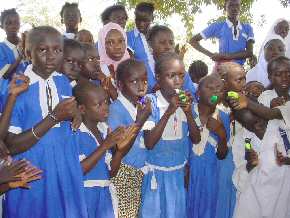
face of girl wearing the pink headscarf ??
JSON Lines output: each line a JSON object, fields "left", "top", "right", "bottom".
{"left": 105, "top": 29, "right": 126, "bottom": 61}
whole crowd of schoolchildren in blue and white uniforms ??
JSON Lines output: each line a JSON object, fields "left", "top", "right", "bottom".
{"left": 0, "top": 0, "right": 290, "bottom": 218}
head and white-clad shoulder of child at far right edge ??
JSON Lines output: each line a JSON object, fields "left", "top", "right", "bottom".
{"left": 258, "top": 56, "right": 290, "bottom": 107}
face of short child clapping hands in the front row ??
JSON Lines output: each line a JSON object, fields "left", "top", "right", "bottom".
{"left": 83, "top": 88, "right": 109, "bottom": 123}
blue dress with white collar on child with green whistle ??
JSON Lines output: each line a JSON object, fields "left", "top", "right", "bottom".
{"left": 187, "top": 105, "right": 228, "bottom": 218}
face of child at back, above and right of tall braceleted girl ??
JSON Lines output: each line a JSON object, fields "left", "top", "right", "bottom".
{"left": 63, "top": 7, "right": 81, "bottom": 30}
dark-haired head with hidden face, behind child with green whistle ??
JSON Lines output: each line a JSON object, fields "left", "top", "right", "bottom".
{"left": 188, "top": 60, "right": 208, "bottom": 85}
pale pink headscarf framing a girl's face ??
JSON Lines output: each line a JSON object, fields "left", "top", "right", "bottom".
{"left": 98, "top": 23, "right": 130, "bottom": 70}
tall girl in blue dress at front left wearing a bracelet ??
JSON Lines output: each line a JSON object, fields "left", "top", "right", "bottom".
{"left": 4, "top": 26, "right": 87, "bottom": 218}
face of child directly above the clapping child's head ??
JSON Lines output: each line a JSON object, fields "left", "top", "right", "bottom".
{"left": 81, "top": 47, "right": 101, "bottom": 80}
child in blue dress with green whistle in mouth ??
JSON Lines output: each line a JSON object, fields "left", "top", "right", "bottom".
{"left": 187, "top": 75, "right": 230, "bottom": 218}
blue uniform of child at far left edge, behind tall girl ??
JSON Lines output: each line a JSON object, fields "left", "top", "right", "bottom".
{"left": 0, "top": 39, "right": 28, "bottom": 113}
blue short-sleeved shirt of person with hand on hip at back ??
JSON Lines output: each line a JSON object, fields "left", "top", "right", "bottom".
{"left": 201, "top": 19, "right": 254, "bottom": 65}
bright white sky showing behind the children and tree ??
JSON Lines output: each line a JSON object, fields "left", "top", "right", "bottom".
{"left": 0, "top": 0, "right": 290, "bottom": 70}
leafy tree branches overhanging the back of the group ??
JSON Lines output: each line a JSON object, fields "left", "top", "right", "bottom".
{"left": 118, "top": 0, "right": 289, "bottom": 36}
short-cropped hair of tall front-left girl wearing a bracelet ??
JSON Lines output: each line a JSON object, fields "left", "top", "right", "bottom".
{"left": 28, "top": 26, "right": 63, "bottom": 50}
